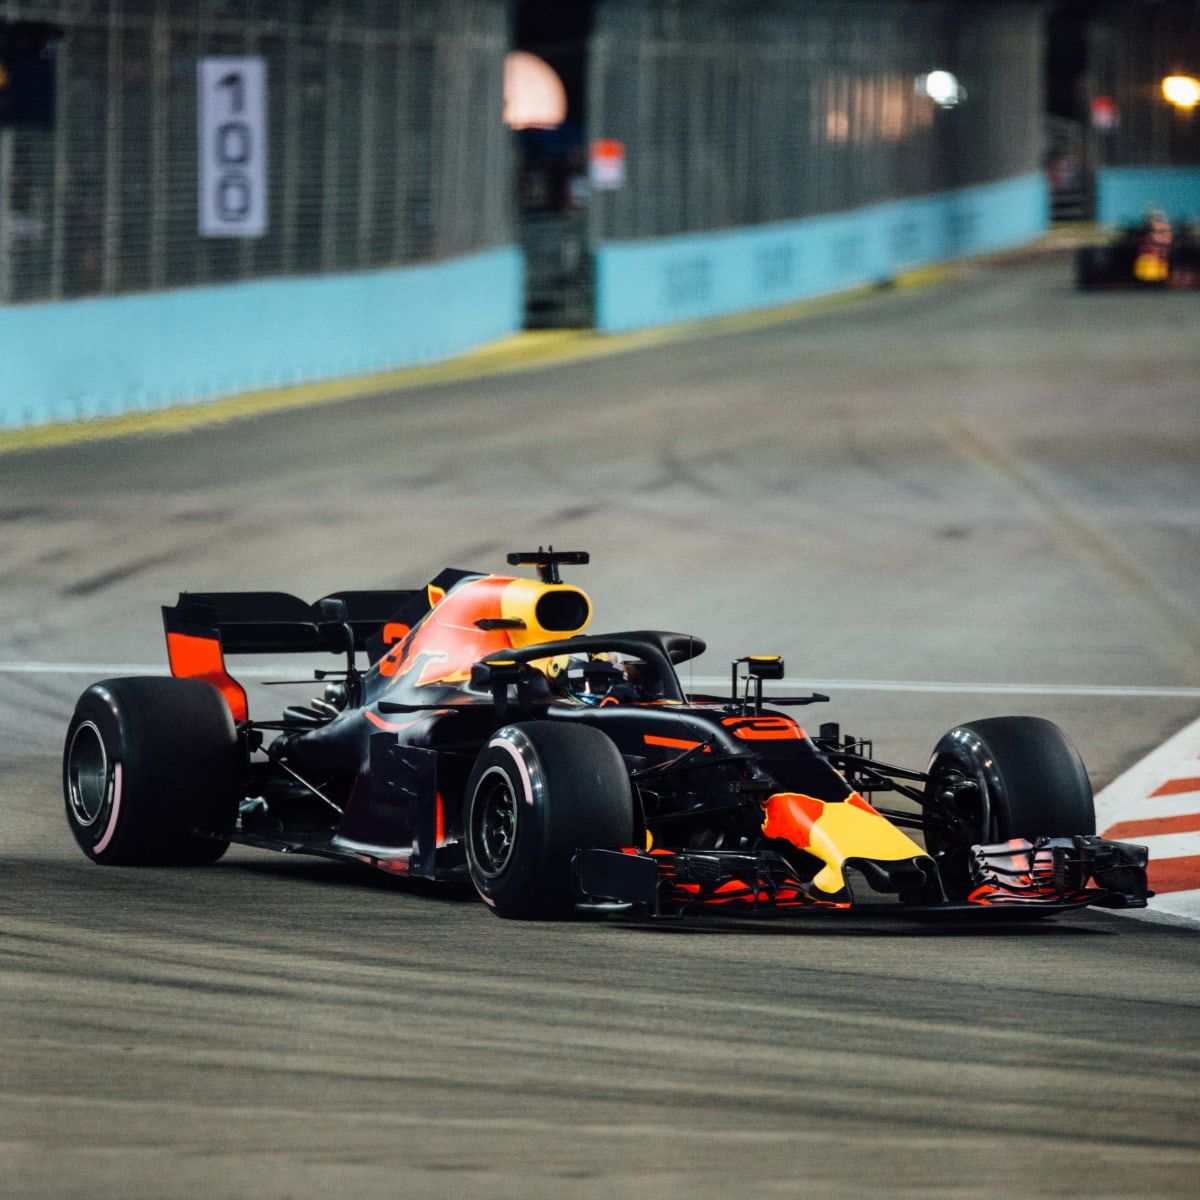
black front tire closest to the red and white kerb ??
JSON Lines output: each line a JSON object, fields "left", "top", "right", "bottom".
{"left": 925, "top": 716, "right": 1096, "bottom": 854}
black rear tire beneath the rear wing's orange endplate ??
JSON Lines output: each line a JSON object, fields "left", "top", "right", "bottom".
{"left": 62, "top": 678, "right": 242, "bottom": 866}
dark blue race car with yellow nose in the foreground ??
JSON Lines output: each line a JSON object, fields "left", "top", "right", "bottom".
{"left": 64, "top": 550, "right": 1147, "bottom": 918}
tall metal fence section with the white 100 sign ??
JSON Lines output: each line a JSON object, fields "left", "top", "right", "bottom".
{"left": 0, "top": 0, "right": 514, "bottom": 304}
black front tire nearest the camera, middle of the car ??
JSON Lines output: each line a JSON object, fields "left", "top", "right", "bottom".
{"left": 463, "top": 721, "right": 634, "bottom": 920}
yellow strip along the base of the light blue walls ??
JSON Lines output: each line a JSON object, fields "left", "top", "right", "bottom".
{"left": 0, "top": 266, "right": 954, "bottom": 454}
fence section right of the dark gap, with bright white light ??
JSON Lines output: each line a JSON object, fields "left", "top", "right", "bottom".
{"left": 589, "top": 0, "right": 1043, "bottom": 244}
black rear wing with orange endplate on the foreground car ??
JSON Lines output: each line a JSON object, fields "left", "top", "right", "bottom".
{"left": 162, "top": 588, "right": 417, "bottom": 721}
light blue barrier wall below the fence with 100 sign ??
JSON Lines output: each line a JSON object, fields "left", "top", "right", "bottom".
{"left": 0, "top": 246, "right": 524, "bottom": 426}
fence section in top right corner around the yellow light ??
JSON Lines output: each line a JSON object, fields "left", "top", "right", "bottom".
{"left": 1088, "top": 0, "right": 1200, "bottom": 167}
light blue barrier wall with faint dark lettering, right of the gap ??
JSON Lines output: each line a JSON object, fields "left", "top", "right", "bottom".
{"left": 596, "top": 174, "right": 1049, "bottom": 332}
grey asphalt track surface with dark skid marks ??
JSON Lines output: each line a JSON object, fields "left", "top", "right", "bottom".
{"left": 0, "top": 259, "right": 1200, "bottom": 1200}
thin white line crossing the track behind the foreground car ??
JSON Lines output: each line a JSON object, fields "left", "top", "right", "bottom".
{"left": 0, "top": 661, "right": 1200, "bottom": 700}
